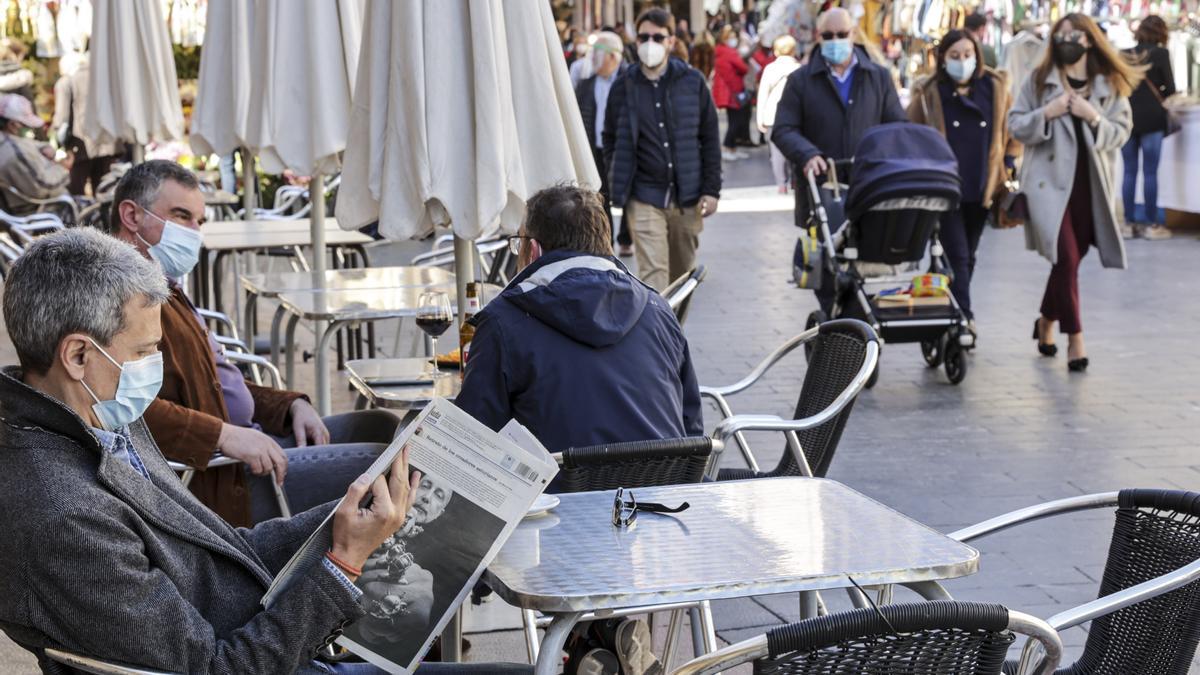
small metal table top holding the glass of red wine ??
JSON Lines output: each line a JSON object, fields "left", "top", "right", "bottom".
{"left": 346, "top": 359, "right": 462, "bottom": 411}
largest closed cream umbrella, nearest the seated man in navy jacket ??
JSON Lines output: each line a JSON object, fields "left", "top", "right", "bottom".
{"left": 337, "top": 0, "right": 600, "bottom": 326}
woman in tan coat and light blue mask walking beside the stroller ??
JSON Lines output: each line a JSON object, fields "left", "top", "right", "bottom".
{"left": 908, "top": 30, "right": 1020, "bottom": 334}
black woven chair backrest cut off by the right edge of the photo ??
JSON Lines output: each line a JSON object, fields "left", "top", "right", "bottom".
{"left": 1075, "top": 490, "right": 1200, "bottom": 675}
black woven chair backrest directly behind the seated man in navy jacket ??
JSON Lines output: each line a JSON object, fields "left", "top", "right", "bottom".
{"left": 557, "top": 436, "right": 713, "bottom": 492}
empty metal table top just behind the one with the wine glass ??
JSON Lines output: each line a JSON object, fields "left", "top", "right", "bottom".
{"left": 241, "top": 267, "right": 454, "bottom": 298}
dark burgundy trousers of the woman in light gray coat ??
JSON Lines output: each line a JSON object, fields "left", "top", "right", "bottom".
{"left": 1042, "top": 177, "right": 1096, "bottom": 334}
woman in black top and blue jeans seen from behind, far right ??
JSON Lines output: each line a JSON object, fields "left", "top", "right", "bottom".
{"left": 1121, "top": 14, "right": 1175, "bottom": 239}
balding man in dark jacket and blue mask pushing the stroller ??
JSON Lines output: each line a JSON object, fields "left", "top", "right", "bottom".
{"left": 770, "top": 7, "right": 908, "bottom": 312}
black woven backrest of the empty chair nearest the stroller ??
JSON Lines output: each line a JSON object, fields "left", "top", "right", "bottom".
{"left": 770, "top": 319, "right": 877, "bottom": 477}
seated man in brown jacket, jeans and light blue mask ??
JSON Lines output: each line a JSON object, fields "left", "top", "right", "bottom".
{"left": 110, "top": 161, "right": 398, "bottom": 525}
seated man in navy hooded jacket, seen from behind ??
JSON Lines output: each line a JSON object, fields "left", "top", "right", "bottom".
{"left": 456, "top": 185, "right": 704, "bottom": 468}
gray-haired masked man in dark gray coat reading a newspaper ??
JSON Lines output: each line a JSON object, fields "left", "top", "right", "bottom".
{"left": 0, "top": 228, "right": 458, "bottom": 674}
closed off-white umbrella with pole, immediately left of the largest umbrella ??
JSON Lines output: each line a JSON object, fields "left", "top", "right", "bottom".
{"left": 245, "top": 0, "right": 364, "bottom": 414}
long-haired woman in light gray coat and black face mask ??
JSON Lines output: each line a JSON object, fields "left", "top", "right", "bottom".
{"left": 1008, "top": 14, "right": 1141, "bottom": 372}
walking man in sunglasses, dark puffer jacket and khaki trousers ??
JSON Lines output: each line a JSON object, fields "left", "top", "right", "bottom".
{"left": 602, "top": 8, "right": 721, "bottom": 291}
